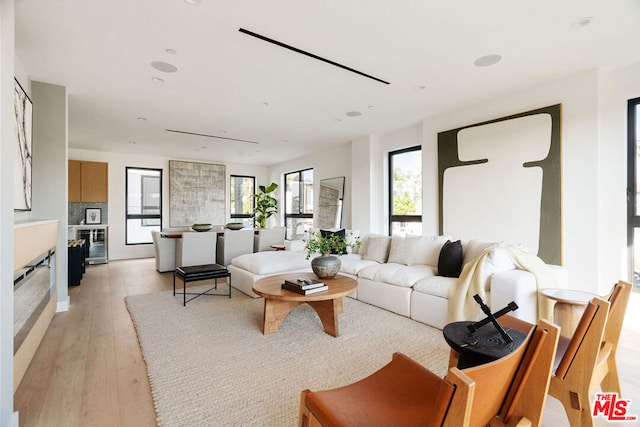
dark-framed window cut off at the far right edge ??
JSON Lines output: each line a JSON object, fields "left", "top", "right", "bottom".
{"left": 627, "top": 98, "right": 640, "bottom": 288}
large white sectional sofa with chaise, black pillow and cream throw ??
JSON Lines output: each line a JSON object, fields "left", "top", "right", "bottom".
{"left": 229, "top": 235, "right": 567, "bottom": 329}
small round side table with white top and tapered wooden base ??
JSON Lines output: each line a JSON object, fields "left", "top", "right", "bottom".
{"left": 540, "top": 289, "right": 598, "bottom": 338}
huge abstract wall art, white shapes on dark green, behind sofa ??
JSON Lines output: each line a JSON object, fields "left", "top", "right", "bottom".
{"left": 438, "top": 104, "right": 562, "bottom": 264}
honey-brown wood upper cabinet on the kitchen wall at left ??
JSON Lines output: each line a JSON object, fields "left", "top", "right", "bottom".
{"left": 68, "top": 160, "right": 109, "bottom": 203}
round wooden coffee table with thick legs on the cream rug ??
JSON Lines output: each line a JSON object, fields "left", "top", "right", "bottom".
{"left": 253, "top": 273, "right": 358, "bottom": 337}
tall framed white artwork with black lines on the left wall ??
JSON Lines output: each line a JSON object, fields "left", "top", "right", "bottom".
{"left": 13, "top": 79, "right": 33, "bottom": 211}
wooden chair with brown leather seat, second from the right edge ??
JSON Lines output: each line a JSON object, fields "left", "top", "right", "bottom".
{"left": 549, "top": 297, "right": 612, "bottom": 427}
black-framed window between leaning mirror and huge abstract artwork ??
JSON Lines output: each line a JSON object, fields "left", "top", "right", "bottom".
{"left": 389, "top": 147, "right": 422, "bottom": 235}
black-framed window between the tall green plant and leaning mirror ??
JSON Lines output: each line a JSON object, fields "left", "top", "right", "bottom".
{"left": 284, "top": 169, "right": 313, "bottom": 239}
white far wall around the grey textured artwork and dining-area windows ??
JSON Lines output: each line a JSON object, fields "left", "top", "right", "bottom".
{"left": 69, "top": 148, "right": 267, "bottom": 260}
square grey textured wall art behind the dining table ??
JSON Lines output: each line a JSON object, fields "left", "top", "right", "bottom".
{"left": 169, "top": 160, "right": 226, "bottom": 227}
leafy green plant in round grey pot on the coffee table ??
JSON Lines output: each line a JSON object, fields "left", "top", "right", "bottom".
{"left": 305, "top": 231, "right": 361, "bottom": 279}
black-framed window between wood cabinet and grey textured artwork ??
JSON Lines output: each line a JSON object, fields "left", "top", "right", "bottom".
{"left": 125, "top": 167, "right": 162, "bottom": 245}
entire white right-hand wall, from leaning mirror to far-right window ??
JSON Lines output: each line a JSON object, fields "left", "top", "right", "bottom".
{"left": 344, "top": 64, "right": 640, "bottom": 294}
